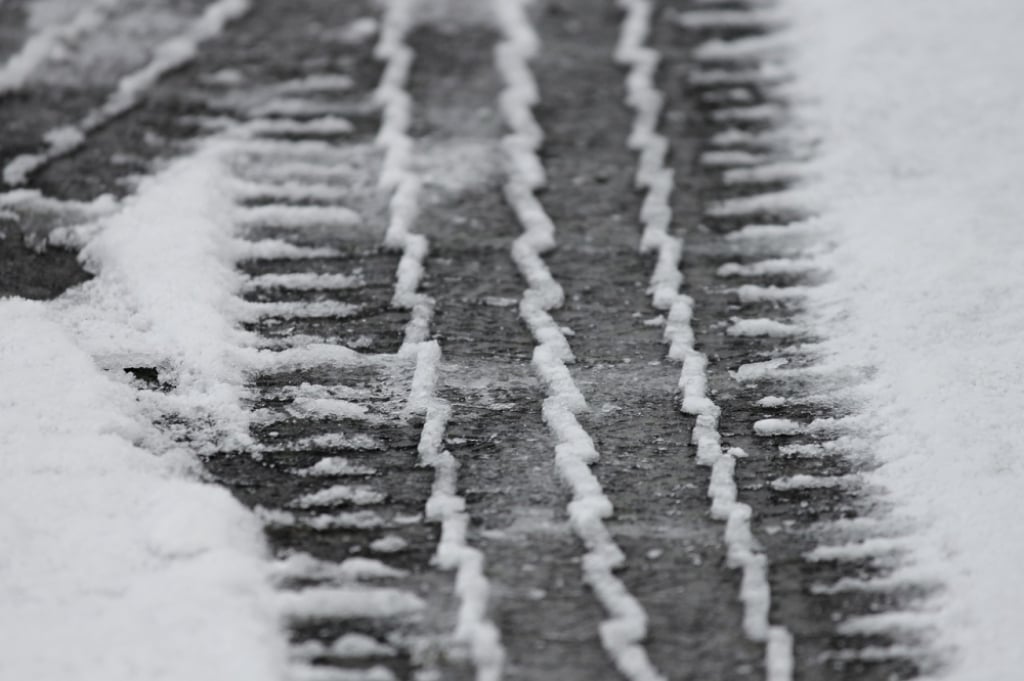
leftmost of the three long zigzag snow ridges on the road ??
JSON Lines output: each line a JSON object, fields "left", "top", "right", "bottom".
{"left": 375, "top": 0, "right": 505, "bottom": 681}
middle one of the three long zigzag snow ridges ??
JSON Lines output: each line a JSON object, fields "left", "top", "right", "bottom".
{"left": 494, "top": 0, "right": 665, "bottom": 681}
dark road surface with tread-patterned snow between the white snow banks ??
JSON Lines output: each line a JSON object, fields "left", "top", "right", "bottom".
{"left": 0, "top": 0, "right": 930, "bottom": 681}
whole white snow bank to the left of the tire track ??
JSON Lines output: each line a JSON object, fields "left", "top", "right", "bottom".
{"left": 0, "top": 144, "right": 287, "bottom": 681}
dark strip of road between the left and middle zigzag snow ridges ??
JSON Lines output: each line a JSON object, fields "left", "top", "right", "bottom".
{"left": 401, "top": 14, "right": 616, "bottom": 681}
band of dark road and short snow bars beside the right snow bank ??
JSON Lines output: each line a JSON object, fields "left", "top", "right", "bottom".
{"left": 670, "top": 2, "right": 931, "bottom": 680}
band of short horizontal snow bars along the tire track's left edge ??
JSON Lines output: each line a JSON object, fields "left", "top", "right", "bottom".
{"left": 209, "top": 99, "right": 437, "bottom": 681}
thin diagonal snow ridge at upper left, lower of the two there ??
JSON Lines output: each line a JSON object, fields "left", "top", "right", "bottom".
{"left": 3, "top": 0, "right": 251, "bottom": 184}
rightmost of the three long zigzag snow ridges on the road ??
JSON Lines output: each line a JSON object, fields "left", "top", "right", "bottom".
{"left": 614, "top": 0, "right": 793, "bottom": 681}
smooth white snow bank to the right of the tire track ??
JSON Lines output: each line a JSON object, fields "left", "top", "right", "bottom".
{"left": 784, "top": 0, "right": 1024, "bottom": 681}
